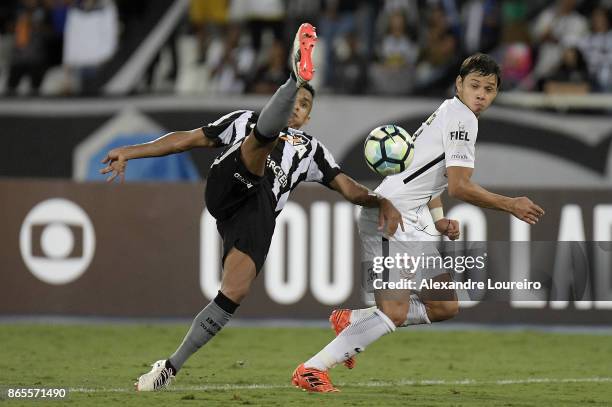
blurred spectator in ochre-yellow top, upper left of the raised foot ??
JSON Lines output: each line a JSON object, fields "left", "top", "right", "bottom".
{"left": 189, "top": 0, "right": 229, "bottom": 62}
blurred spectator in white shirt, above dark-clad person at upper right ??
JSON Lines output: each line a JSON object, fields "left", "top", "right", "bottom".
{"left": 532, "top": 0, "right": 588, "bottom": 81}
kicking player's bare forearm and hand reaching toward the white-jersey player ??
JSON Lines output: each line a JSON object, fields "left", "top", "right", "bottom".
{"left": 329, "top": 173, "right": 404, "bottom": 236}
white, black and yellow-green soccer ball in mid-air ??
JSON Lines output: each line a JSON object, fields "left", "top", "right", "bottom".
{"left": 363, "top": 124, "right": 414, "bottom": 177}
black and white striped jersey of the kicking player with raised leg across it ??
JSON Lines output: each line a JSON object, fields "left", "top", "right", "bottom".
{"left": 202, "top": 110, "right": 341, "bottom": 215}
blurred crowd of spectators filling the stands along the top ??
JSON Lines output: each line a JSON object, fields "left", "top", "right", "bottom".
{"left": 0, "top": 0, "right": 612, "bottom": 96}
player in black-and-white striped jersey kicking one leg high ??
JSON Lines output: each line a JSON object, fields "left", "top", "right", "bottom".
{"left": 101, "top": 24, "right": 403, "bottom": 391}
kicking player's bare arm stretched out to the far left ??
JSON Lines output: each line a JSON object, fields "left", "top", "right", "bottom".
{"left": 100, "top": 128, "right": 217, "bottom": 182}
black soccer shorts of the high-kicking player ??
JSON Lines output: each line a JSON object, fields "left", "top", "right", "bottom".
{"left": 205, "top": 143, "right": 276, "bottom": 274}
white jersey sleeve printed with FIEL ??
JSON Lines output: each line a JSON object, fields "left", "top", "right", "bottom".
{"left": 442, "top": 115, "right": 478, "bottom": 168}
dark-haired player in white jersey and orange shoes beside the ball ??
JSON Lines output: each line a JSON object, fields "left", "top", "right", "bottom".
{"left": 292, "top": 54, "right": 544, "bottom": 392}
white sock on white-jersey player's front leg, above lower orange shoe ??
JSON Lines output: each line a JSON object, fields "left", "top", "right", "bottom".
{"left": 304, "top": 309, "right": 395, "bottom": 371}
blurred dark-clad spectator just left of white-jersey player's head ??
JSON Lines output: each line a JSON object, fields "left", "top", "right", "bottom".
{"left": 415, "top": 5, "right": 460, "bottom": 92}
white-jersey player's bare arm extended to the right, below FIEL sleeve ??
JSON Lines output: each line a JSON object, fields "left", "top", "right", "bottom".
{"left": 447, "top": 167, "right": 544, "bottom": 225}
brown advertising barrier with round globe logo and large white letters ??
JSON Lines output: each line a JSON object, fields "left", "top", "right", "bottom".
{"left": 0, "top": 179, "right": 612, "bottom": 325}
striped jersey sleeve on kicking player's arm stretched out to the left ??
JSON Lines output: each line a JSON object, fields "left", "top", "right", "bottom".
{"left": 202, "top": 110, "right": 256, "bottom": 147}
